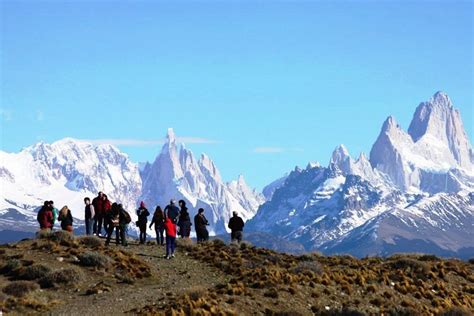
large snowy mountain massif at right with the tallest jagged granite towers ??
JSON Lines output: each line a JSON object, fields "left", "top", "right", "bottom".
{"left": 247, "top": 92, "right": 474, "bottom": 256}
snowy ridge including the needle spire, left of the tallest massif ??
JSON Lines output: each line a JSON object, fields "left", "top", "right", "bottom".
{"left": 0, "top": 130, "right": 263, "bottom": 241}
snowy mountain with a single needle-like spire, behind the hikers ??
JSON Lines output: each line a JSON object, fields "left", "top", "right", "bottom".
{"left": 142, "top": 129, "right": 264, "bottom": 234}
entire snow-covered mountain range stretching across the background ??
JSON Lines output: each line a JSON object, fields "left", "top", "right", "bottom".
{"left": 0, "top": 92, "right": 474, "bottom": 258}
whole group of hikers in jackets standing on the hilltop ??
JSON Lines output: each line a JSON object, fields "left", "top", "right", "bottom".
{"left": 37, "top": 192, "right": 248, "bottom": 259}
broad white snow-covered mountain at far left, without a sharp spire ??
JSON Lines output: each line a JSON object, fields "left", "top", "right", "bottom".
{"left": 0, "top": 138, "right": 141, "bottom": 239}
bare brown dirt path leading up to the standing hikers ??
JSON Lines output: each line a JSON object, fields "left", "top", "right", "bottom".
{"left": 50, "top": 243, "right": 231, "bottom": 315}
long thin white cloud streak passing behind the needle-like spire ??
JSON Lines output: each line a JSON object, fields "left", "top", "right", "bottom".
{"left": 80, "top": 137, "right": 219, "bottom": 147}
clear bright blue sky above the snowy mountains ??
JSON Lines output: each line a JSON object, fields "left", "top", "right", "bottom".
{"left": 0, "top": 0, "right": 474, "bottom": 189}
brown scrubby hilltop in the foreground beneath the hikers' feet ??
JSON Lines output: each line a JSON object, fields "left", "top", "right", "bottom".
{"left": 0, "top": 232, "right": 474, "bottom": 315}
